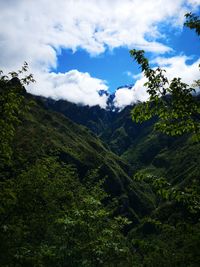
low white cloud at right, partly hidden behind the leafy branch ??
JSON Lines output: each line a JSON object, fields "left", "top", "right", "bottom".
{"left": 114, "top": 55, "right": 200, "bottom": 109}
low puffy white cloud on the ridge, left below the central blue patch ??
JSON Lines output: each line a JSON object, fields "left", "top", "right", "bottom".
{"left": 29, "top": 70, "right": 108, "bottom": 108}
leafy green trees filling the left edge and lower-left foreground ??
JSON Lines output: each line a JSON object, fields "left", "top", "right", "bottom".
{"left": 0, "top": 68, "right": 132, "bottom": 267}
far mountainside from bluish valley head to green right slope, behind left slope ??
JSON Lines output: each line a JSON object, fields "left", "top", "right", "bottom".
{"left": 41, "top": 98, "right": 200, "bottom": 188}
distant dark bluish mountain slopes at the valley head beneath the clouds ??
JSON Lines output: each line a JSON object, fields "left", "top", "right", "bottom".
{"left": 37, "top": 97, "right": 152, "bottom": 155}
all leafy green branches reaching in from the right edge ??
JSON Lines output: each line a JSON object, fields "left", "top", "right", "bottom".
{"left": 130, "top": 13, "right": 200, "bottom": 211}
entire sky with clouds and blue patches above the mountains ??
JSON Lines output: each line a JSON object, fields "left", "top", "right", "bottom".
{"left": 0, "top": 0, "right": 200, "bottom": 108}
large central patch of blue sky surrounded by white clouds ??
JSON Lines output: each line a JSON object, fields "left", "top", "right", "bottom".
{"left": 52, "top": 48, "right": 135, "bottom": 92}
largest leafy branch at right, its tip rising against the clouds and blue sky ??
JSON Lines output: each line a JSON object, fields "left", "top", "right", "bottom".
{"left": 130, "top": 49, "right": 200, "bottom": 139}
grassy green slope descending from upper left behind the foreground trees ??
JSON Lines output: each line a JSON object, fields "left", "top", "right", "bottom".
{"left": 11, "top": 95, "right": 153, "bottom": 222}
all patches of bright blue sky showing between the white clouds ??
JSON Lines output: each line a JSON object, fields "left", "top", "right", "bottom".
{"left": 54, "top": 23, "right": 200, "bottom": 92}
